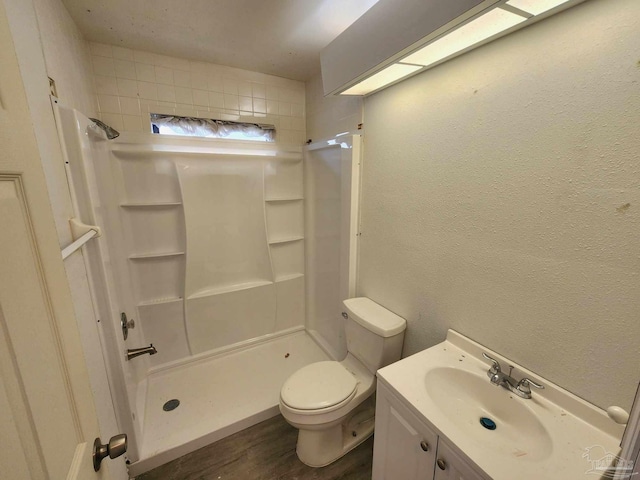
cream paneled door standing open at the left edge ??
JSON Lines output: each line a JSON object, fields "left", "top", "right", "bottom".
{"left": 0, "top": 2, "right": 110, "bottom": 480}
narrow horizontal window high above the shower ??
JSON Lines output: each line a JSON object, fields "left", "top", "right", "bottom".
{"left": 150, "top": 113, "right": 276, "bottom": 142}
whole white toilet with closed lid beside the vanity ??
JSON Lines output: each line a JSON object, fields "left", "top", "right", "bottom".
{"left": 280, "top": 297, "right": 406, "bottom": 467}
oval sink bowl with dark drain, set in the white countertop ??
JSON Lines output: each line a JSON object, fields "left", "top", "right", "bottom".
{"left": 424, "top": 367, "right": 552, "bottom": 461}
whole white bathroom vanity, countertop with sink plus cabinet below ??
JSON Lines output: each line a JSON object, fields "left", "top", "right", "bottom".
{"left": 373, "top": 330, "right": 624, "bottom": 480}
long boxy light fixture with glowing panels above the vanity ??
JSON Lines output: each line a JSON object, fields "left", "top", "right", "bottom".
{"left": 322, "top": 0, "right": 584, "bottom": 95}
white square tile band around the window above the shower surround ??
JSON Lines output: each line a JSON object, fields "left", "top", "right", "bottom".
{"left": 90, "top": 43, "right": 306, "bottom": 145}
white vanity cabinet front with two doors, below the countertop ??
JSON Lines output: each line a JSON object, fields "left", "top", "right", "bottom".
{"left": 373, "top": 382, "right": 486, "bottom": 480}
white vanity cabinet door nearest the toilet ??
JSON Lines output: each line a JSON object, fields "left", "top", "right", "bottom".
{"left": 373, "top": 384, "right": 438, "bottom": 480}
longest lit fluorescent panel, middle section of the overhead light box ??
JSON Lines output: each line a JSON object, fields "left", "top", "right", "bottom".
{"left": 401, "top": 7, "right": 524, "bottom": 66}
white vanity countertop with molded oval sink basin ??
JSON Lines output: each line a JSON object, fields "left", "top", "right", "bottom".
{"left": 377, "top": 330, "right": 624, "bottom": 480}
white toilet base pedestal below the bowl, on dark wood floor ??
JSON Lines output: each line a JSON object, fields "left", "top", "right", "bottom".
{"left": 296, "top": 396, "right": 375, "bottom": 467}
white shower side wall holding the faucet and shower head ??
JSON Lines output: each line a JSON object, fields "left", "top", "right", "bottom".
{"left": 53, "top": 104, "right": 149, "bottom": 462}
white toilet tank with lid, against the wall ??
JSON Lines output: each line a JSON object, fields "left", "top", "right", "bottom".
{"left": 343, "top": 297, "right": 407, "bottom": 373}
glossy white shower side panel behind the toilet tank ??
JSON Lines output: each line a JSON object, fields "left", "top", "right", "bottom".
{"left": 304, "top": 135, "right": 361, "bottom": 359}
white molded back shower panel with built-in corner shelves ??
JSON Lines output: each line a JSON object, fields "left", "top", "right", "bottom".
{"left": 111, "top": 142, "right": 305, "bottom": 367}
